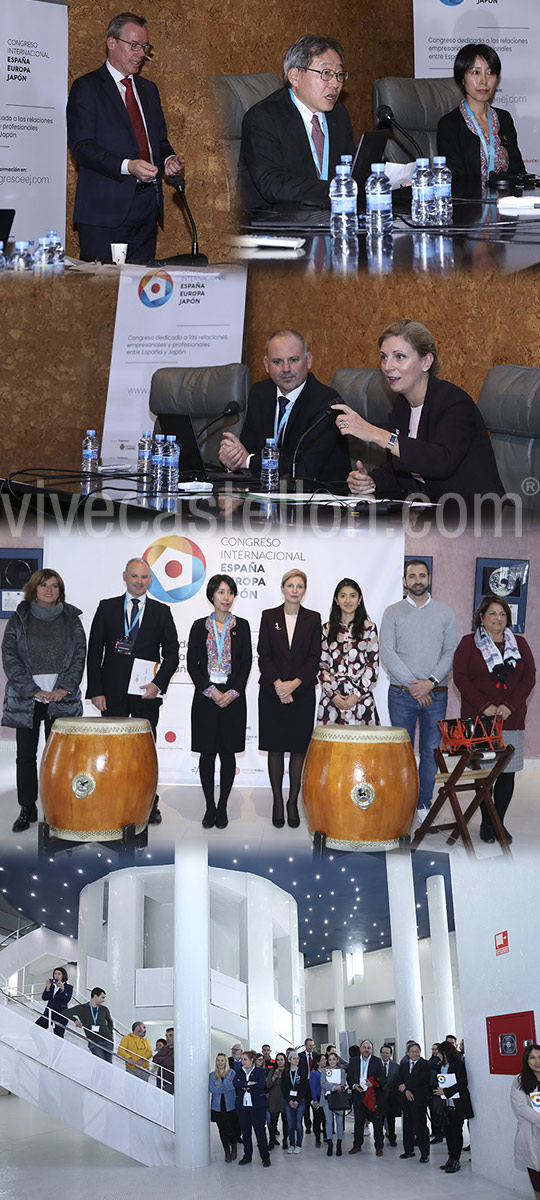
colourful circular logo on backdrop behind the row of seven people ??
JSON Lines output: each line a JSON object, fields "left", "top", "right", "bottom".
{"left": 143, "top": 534, "right": 206, "bottom": 604}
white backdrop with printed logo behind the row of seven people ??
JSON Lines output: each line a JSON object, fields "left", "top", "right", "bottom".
{"left": 43, "top": 526, "right": 403, "bottom": 787}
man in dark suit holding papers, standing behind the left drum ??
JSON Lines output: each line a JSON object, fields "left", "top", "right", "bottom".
{"left": 86, "top": 558, "right": 179, "bottom": 824}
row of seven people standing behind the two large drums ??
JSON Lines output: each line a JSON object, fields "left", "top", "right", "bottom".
{"left": 2, "top": 559, "right": 535, "bottom": 842}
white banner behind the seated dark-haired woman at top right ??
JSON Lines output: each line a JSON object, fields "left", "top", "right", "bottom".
{"left": 414, "top": 0, "right": 540, "bottom": 172}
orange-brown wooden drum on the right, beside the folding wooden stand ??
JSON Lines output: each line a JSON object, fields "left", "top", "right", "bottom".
{"left": 302, "top": 725, "right": 418, "bottom": 850}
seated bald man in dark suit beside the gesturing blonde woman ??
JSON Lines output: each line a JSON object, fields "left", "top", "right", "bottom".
{"left": 220, "top": 329, "right": 350, "bottom": 481}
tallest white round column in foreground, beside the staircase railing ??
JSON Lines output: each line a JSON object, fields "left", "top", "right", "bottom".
{"left": 174, "top": 840, "right": 210, "bottom": 1168}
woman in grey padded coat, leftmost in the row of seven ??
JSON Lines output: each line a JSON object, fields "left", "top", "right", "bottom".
{"left": 2, "top": 569, "right": 86, "bottom": 833}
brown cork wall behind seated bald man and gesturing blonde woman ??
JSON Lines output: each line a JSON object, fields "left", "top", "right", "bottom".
{"left": 0, "top": 269, "right": 540, "bottom": 475}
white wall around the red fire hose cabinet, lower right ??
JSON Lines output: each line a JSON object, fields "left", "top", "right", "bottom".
{"left": 450, "top": 851, "right": 540, "bottom": 1196}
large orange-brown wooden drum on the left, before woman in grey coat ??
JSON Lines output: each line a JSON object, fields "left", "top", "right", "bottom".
{"left": 40, "top": 716, "right": 157, "bottom": 841}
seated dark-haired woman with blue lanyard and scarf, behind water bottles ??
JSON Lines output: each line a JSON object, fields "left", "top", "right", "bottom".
{"left": 437, "top": 43, "right": 526, "bottom": 186}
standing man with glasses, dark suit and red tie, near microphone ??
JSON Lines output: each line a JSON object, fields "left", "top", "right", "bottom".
{"left": 67, "top": 12, "right": 184, "bottom": 263}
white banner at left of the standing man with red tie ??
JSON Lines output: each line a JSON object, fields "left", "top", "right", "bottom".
{"left": 0, "top": 0, "right": 67, "bottom": 245}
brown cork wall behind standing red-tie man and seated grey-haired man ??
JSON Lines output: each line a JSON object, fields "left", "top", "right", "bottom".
{"left": 67, "top": 0, "right": 413, "bottom": 258}
